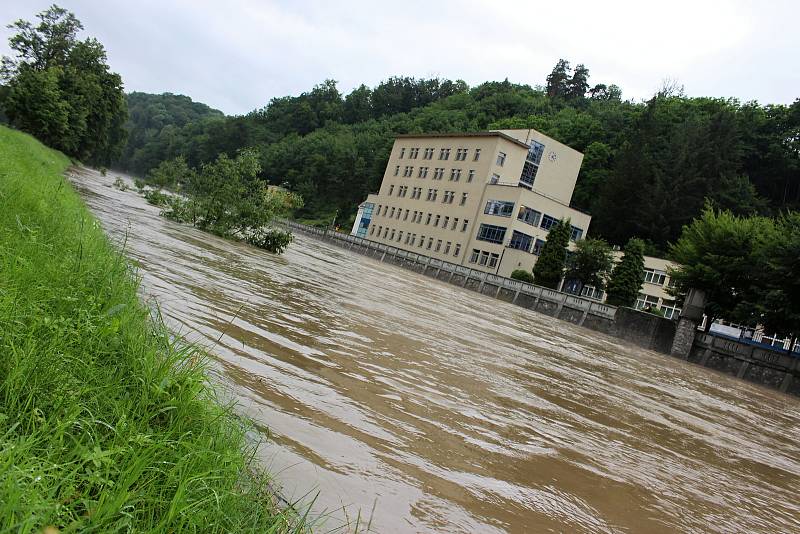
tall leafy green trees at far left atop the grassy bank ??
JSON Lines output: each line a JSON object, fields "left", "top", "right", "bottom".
{"left": 1, "top": 5, "right": 127, "bottom": 165}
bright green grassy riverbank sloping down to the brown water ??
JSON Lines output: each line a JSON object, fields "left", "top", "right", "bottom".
{"left": 0, "top": 127, "right": 290, "bottom": 532}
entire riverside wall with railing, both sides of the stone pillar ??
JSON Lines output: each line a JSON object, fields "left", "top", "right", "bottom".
{"left": 280, "top": 220, "right": 800, "bottom": 395}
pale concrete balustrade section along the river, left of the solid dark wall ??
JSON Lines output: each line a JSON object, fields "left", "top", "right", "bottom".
{"left": 279, "top": 219, "right": 617, "bottom": 325}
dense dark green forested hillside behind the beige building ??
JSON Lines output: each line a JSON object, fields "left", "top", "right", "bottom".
{"left": 115, "top": 66, "right": 800, "bottom": 251}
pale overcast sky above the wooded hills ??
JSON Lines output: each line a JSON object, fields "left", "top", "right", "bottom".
{"left": 0, "top": 0, "right": 800, "bottom": 114}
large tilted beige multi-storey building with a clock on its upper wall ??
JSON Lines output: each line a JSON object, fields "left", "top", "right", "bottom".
{"left": 354, "top": 130, "right": 591, "bottom": 276}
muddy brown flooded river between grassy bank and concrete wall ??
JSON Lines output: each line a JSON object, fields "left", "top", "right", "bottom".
{"left": 73, "top": 172, "right": 800, "bottom": 533}
